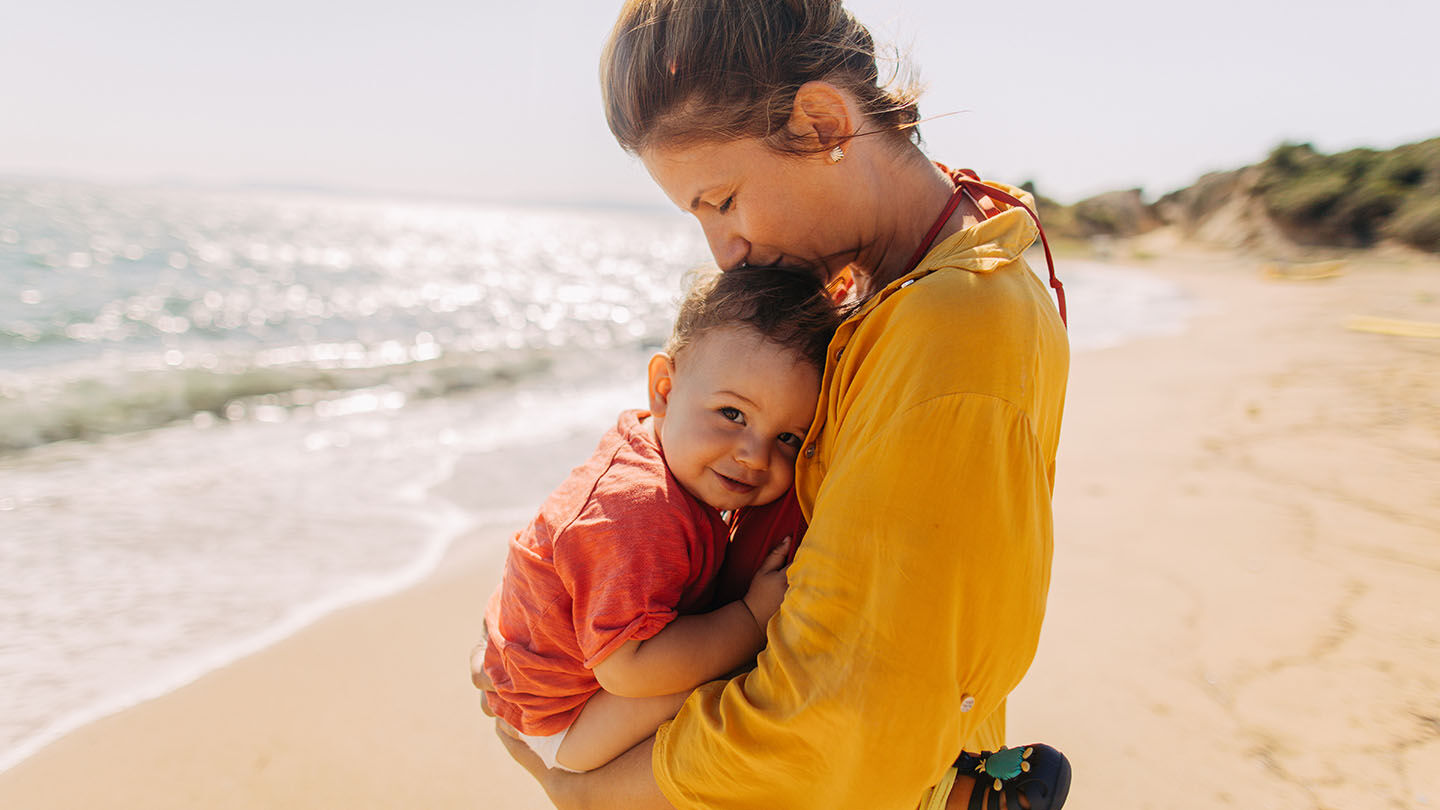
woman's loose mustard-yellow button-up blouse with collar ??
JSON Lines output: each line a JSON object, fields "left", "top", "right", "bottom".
{"left": 652, "top": 187, "right": 1070, "bottom": 810}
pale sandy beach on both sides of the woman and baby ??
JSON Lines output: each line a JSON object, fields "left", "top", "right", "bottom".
{"left": 0, "top": 249, "right": 1440, "bottom": 810}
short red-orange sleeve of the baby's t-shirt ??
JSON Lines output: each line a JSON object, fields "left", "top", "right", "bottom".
{"left": 554, "top": 493, "right": 696, "bottom": 669}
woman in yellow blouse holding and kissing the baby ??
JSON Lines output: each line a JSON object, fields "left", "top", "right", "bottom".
{"left": 478, "top": 0, "right": 1068, "bottom": 810}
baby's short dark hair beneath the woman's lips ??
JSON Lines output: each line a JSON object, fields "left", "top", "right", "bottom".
{"left": 665, "top": 265, "right": 844, "bottom": 373}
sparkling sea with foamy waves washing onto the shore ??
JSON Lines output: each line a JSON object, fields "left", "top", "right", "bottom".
{"left": 0, "top": 179, "right": 1191, "bottom": 771}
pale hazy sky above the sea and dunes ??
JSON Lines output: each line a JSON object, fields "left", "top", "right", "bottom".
{"left": 0, "top": 0, "right": 1440, "bottom": 206}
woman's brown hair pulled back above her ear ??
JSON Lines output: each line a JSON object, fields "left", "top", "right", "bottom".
{"left": 600, "top": 0, "right": 920, "bottom": 154}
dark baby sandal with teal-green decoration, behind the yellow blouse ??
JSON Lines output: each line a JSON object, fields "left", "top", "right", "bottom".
{"left": 955, "top": 744, "right": 1070, "bottom": 810}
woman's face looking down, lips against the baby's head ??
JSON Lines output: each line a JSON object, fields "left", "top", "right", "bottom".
{"left": 641, "top": 138, "right": 863, "bottom": 280}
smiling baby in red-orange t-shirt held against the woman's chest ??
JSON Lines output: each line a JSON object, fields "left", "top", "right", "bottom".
{"left": 484, "top": 268, "right": 840, "bottom": 771}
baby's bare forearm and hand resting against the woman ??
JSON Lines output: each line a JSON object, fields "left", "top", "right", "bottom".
{"left": 595, "top": 540, "right": 789, "bottom": 698}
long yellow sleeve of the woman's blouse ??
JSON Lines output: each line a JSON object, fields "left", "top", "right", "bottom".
{"left": 652, "top": 393, "right": 1051, "bottom": 810}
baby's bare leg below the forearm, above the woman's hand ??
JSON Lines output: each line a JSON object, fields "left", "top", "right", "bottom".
{"left": 554, "top": 689, "right": 690, "bottom": 771}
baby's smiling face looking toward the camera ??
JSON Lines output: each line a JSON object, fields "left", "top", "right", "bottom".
{"left": 651, "top": 327, "right": 819, "bottom": 510}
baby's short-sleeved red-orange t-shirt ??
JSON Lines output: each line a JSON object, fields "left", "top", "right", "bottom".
{"left": 485, "top": 411, "right": 729, "bottom": 735}
